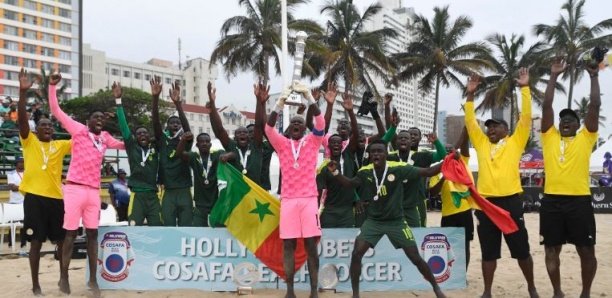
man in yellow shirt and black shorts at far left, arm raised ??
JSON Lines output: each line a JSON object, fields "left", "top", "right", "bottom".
{"left": 13, "top": 68, "right": 71, "bottom": 296}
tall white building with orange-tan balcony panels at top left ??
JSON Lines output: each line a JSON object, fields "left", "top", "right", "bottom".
{"left": 0, "top": 0, "right": 82, "bottom": 98}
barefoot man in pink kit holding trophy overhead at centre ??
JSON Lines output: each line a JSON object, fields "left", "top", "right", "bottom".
{"left": 266, "top": 82, "right": 325, "bottom": 297}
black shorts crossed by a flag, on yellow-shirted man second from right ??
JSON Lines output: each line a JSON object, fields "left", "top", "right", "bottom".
{"left": 475, "top": 194, "right": 530, "bottom": 261}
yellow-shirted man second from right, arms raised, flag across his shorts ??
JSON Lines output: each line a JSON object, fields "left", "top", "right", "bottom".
{"left": 464, "top": 68, "right": 538, "bottom": 297}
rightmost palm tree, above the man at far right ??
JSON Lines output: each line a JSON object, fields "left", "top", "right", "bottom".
{"left": 533, "top": 0, "right": 612, "bottom": 108}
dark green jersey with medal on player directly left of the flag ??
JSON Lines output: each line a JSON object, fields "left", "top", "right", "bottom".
{"left": 189, "top": 150, "right": 225, "bottom": 210}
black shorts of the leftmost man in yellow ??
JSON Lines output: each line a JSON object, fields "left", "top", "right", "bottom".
{"left": 23, "top": 193, "right": 66, "bottom": 242}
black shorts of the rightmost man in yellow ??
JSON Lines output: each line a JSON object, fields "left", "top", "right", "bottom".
{"left": 540, "top": 194, "right": 595, "bottom": 247}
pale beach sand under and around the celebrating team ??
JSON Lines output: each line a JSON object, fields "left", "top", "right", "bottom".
{"left": 0, "top": 212, "right": 612, "bottom": 298}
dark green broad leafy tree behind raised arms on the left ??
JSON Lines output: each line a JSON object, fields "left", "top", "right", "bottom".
{"left": 60, "top": 87, "right": 171, "bottom": 135}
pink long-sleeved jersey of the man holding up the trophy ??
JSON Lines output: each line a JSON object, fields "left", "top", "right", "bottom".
{"left": 265, "top": 114, "right": 325, "bottom": 199}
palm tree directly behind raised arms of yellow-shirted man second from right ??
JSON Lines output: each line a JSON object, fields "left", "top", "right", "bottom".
{"left": 478, "top": 34, "right": 565, "bottom": 131}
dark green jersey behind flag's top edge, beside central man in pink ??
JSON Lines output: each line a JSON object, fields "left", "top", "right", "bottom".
{"left": 225, "top": 140, "right": 263, "bottom": 186}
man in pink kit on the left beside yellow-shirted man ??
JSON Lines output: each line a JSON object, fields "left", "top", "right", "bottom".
{"left": 49, "top": 73, "right": 125, "bottom": 296}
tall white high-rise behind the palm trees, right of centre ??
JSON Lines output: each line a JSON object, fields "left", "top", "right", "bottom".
{"left": 366, "top": 0, "right": 435, "bottom": 134}
